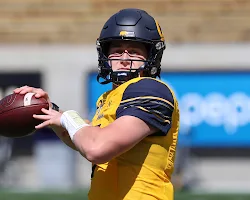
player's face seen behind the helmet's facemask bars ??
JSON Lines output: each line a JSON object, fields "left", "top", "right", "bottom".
{"left": 108, "top": 41, "right": 147, "bottom": 71}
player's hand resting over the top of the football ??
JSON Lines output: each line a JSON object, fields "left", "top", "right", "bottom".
{"left": 13, "top": 85, "right": 52, "bottom": 108}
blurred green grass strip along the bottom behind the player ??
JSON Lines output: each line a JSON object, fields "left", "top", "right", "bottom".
{"left": 0, "top": 191, "right": 250, "bottom": 200}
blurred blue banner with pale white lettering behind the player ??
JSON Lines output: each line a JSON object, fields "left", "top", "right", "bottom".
{"left": 88, "top": 71, "right": 250, "bottom": 147}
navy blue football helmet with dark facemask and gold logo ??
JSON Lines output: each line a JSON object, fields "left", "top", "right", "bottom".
{"left": 96, "top": 8, "right": 165, "bottom": 84}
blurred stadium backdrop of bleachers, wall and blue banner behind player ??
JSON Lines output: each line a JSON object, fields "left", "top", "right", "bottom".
{"left": 0, "top": 0, "right": 250, "bottom": 200}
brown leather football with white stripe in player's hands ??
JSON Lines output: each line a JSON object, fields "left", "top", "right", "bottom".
{"left": 0, "top": 93, "right": 49, "bottom": 138}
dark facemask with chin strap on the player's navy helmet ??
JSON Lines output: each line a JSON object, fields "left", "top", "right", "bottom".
{"left": 97, "top": 40, "right": 163, "bottom": 85}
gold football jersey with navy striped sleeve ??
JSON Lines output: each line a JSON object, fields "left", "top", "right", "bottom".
{"left": 89, "top": 77, "right": 179, "bottom": 200}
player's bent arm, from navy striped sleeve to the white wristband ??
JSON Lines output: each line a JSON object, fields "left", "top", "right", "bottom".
{"left": 73, "top": 79, "right": 174, "bottom": 164}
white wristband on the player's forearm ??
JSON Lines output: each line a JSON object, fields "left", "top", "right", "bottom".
{"left": 60, "top": 110, "right": 89, "bottom": 141}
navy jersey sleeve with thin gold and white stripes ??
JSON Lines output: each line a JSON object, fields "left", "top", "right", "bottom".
{"left": 116, "top": 79, "right": 174, "bottom": 135}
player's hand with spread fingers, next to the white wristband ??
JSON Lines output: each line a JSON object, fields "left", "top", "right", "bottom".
{"left": 33, "top": 108, "right": 62, "bottom": 129}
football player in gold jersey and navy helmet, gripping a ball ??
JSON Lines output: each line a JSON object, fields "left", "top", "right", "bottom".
{"left": 15, "top": 9, "right": 179, "bottom": 200}
